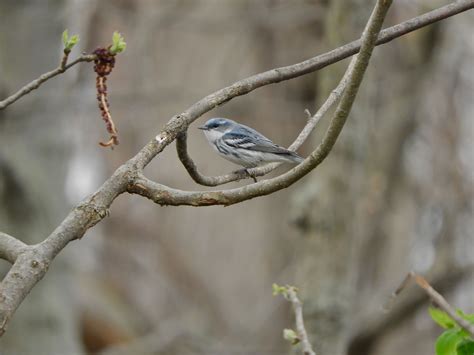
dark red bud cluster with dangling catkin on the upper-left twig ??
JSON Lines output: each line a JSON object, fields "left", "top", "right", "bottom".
{"left": 93, "top": 48, "right": 119, "bottom": 148}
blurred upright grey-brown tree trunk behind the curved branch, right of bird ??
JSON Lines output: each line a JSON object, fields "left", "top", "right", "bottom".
{"left": 294, "top": 0, "right": 372, "bottom": 355}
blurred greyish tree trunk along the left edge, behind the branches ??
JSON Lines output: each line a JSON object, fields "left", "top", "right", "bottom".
{"left": 0, "top": 1, "right": 81, "bottom": 355}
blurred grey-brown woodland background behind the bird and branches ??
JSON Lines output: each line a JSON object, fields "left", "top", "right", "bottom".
{"left": 0, "top": 0, "right": 474, "bottom": 355}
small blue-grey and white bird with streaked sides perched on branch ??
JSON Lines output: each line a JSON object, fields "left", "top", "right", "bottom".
{"left": 199, "top": 118, "right": 303, "bottom": 169}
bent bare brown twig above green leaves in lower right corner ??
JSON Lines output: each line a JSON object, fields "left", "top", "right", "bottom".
{"left": 390, "top": 271, "right": 474, "bottom": 337}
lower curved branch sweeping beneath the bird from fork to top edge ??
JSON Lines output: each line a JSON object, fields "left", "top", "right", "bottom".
{"left": 127, "top": 0, "right": 391, "bottom": 206}
